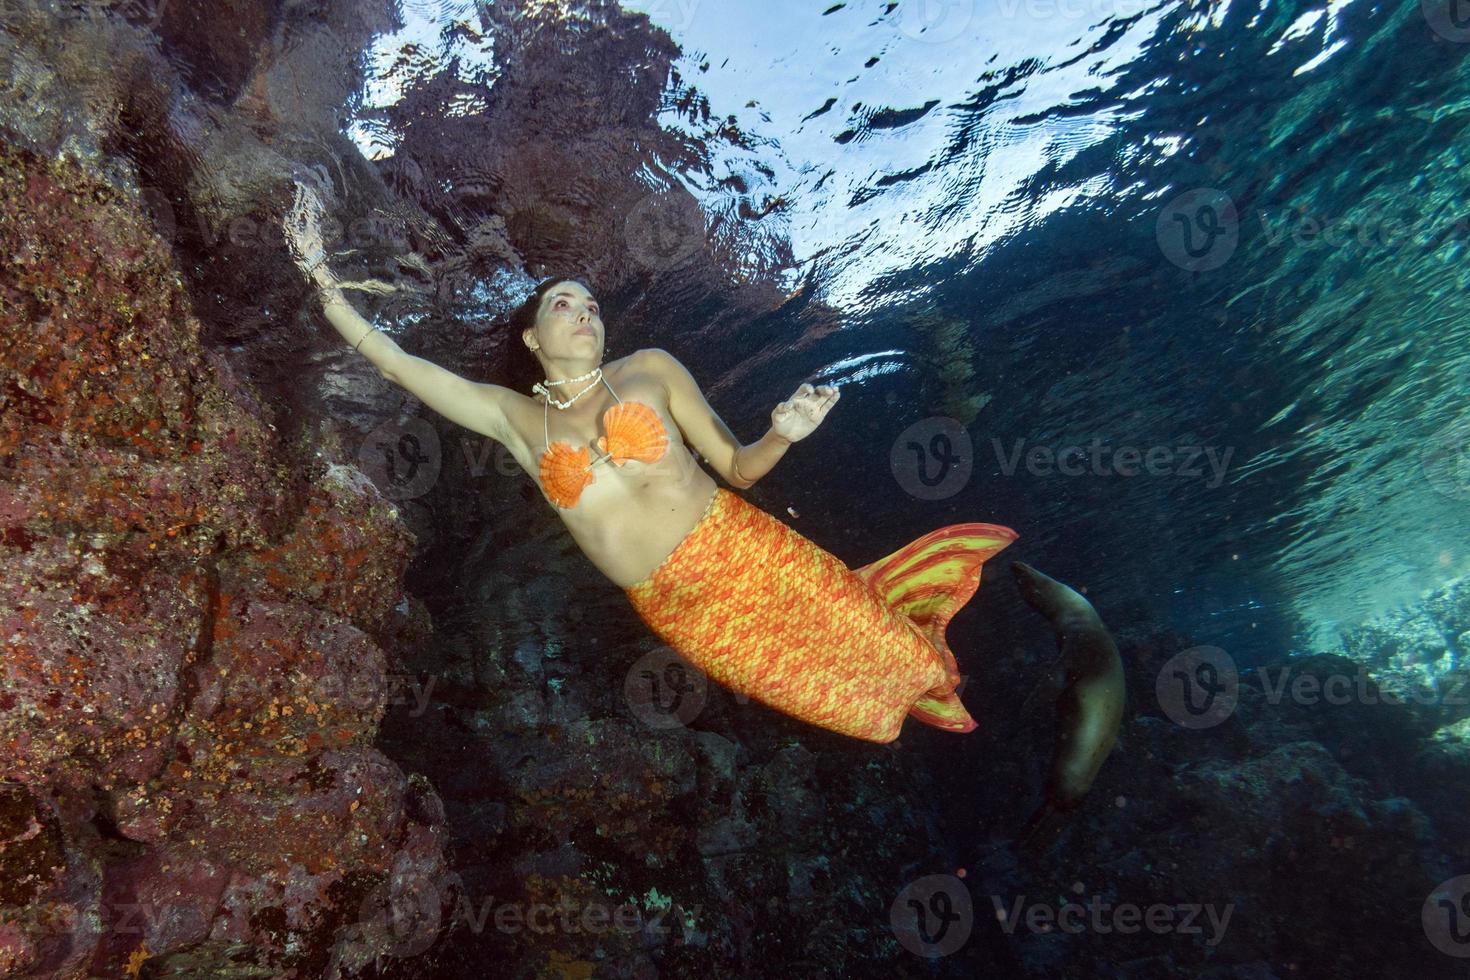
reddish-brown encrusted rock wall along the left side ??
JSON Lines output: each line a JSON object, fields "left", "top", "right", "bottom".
{"left": 0, "top": 141, "right": 444, "bottom": 977}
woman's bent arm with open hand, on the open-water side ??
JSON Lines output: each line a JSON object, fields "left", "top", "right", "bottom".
{"left": 641, "top": 347, "right": 838, "bottom": 489}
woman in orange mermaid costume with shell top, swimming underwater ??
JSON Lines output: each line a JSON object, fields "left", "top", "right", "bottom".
{"left": 287, "top": 184, "right": 1016, "bottom": 742}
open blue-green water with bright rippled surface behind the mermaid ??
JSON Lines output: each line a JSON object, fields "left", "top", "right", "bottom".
{"left": 359, "top": 0, "right": 1470, "bottom": 660}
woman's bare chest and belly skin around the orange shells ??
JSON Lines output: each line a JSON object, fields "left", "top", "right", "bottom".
{"left": 506, "top": 351, "right": 717, "bottom": 588}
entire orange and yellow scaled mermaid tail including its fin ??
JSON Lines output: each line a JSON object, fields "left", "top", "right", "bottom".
{"left": 623, "top": 486, "right": 1017, "bottom": 742}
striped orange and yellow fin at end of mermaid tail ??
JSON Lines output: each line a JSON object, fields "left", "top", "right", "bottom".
{"left": 853, "top": 523, "right": 1016, "bottom": 687}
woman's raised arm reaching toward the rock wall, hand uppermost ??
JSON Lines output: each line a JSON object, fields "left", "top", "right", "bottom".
{"left": 285, "top": 182, "right": 515, "bottom": 442}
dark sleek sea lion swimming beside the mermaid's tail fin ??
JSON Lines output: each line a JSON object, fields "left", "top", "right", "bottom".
{"left": 1011, "top": 561, "right": 1126, "bottom": 849}
